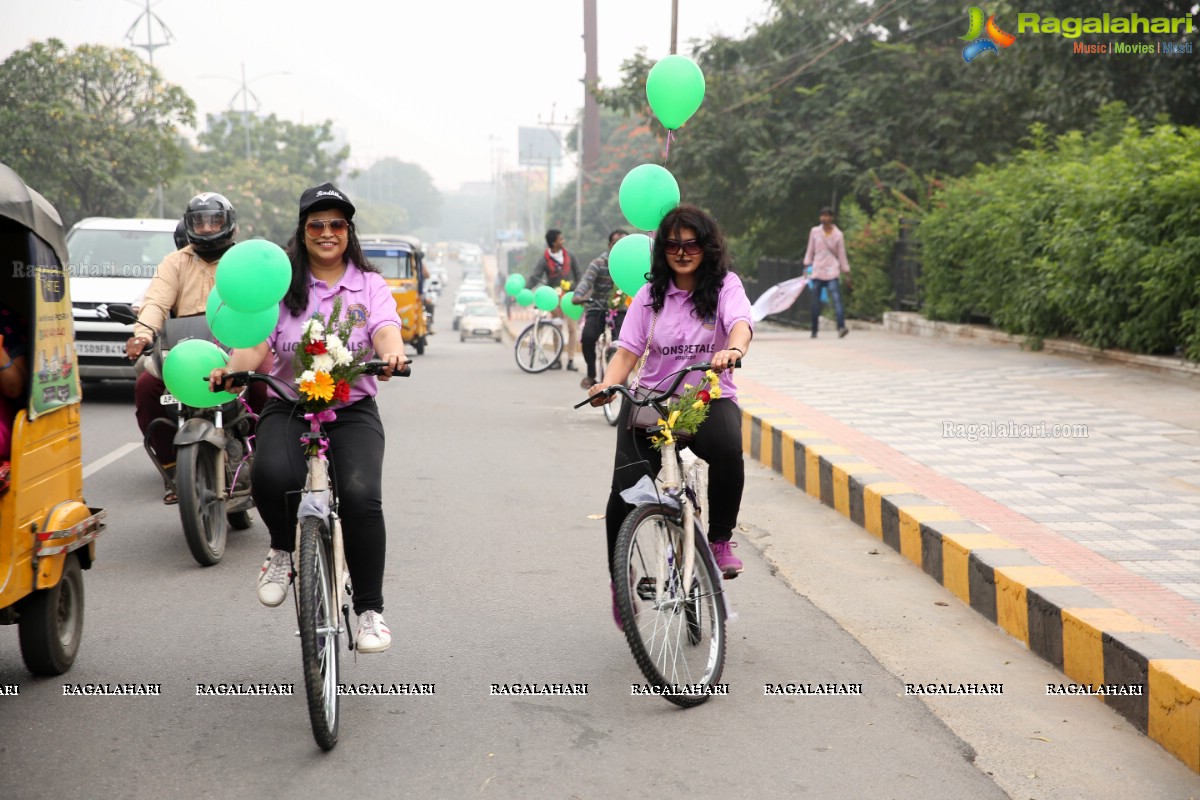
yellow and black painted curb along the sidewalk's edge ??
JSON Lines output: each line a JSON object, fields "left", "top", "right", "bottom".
{"left": 742, "top": 392, "right": 1200, "bottom": 772}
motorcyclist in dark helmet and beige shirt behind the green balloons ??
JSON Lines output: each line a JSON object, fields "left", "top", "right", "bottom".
{"left": 125, "top": 192, "right": 258, "bottom": 505}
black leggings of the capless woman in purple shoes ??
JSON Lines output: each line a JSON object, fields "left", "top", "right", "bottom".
{"left": 605, "top": 398, "right": 745, "bottom": 572}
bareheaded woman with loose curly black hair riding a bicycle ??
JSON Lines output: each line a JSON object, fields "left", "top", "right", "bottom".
{"left": 588, "top": 205, "right": 754, "bottom": 624}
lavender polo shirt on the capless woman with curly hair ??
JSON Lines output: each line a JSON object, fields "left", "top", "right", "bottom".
{"left": 618, "top": 272, "right": 754, "bottom": 402}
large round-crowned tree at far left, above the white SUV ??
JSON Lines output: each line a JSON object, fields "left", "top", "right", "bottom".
{"left": 0, "top": 38, "right": 196, "bottom": 224}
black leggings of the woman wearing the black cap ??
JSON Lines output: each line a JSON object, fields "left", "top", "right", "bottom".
{"left": 253, "top": 397, "right": 388, "bottom": 614}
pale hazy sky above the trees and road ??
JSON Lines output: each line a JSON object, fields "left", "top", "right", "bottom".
{"left": 0, "top": 0, "right": 770, "bottom": 190}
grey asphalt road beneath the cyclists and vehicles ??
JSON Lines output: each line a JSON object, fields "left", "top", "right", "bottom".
{"left": 0, "top": 284, "right": 1192, "bottom": 800}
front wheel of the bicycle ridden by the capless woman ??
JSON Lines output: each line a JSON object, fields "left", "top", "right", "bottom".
{"left": 613, "top": 503, "right": 725, "bottom": 708}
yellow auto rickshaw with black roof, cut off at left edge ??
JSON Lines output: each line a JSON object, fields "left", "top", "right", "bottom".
{"left": 0, "top": 164, "right": 104, "bottom": 675}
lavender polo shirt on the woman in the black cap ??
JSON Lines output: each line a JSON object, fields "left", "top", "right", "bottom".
{"left": 266, "top": 261, "right": 400, "bottom": 408}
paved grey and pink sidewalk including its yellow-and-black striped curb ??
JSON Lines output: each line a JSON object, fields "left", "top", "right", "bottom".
{"left": 738, "top": 326, "right": 1200, "bottom": 770}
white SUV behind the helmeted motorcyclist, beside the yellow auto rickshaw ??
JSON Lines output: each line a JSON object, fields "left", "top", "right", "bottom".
{"left": 67, "top": 217, "right": 179, "bottom": 380}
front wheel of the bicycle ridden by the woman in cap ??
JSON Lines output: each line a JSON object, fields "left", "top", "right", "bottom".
{"left": 296, "top": 517, "right": 340, "bottom": 750}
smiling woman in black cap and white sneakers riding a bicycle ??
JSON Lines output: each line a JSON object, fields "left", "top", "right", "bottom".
{"left": 210, "top": 184, "right": 408, "bottom": 652}
